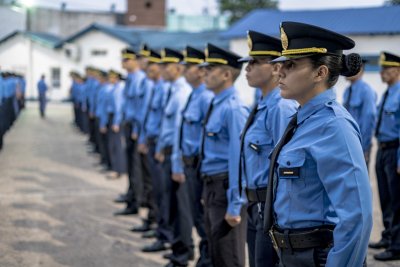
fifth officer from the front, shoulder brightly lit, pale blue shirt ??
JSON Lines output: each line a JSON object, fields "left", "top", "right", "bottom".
{"left": 142, "top": 48, "right": 192, "bottom": 252}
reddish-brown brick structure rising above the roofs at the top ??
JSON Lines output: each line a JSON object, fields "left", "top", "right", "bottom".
{"left": 125, "top": 0, "right": 166, "bottom": 27}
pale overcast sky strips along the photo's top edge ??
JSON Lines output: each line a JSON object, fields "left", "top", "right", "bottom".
{"left": 18, "top": 0, "right": 384, "bottom": 15}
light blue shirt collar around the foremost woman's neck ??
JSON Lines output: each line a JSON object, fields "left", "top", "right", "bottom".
{"left": 297, "top": 88, "right": 336, "bottom": 124}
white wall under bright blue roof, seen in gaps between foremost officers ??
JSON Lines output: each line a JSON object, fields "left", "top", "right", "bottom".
{"left": 230, "top": 35, "right": 400, "bottom": 107}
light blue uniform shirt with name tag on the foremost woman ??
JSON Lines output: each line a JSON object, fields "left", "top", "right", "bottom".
{"left": 274, "top": 89, "right": 372, "bottom": 267}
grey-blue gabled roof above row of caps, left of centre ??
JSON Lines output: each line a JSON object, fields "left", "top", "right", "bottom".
{"left": 58, "top": 23, "right": 229, "bottom": 49}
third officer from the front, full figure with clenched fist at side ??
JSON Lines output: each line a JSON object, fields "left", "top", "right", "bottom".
{"left": 199, "top": 44, "right": 248, "bottom": 267}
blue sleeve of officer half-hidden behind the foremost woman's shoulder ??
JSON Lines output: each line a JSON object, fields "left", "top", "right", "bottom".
{"left": 360, "top": 88, "right": 377, "bottom": 152}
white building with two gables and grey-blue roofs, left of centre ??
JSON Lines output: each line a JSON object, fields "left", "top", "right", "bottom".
{"left": 0, "top": 24, "right": 228, "bottom": 100}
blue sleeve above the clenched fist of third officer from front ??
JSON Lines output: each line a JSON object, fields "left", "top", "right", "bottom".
{"left": 225, "top": 103, "right": 249, "bottom": 216}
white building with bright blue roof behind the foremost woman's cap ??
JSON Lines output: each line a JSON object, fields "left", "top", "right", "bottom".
{"left": 222, "top": 6, "right": 400, "bottom": 103}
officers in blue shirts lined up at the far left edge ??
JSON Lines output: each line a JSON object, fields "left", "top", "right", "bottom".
{"left": 0, "top": 72, "right": 26, "bottom": 150}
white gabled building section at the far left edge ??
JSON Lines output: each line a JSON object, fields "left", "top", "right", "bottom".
{"left": 0, "top": 31, "right": 73, "bottom": 99}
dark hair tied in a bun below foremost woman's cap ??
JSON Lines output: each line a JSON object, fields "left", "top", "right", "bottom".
{"left": 310, "top": 53, "right": 362, "bottom": 87}
